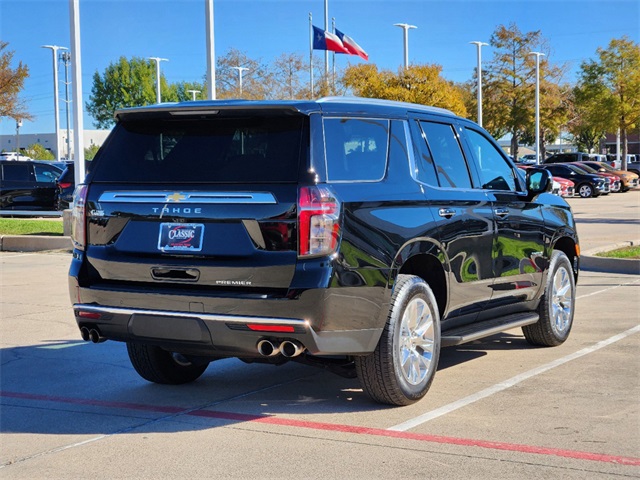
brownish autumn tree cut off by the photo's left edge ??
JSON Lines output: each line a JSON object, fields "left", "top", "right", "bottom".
{"left": 0, "top": 40, "right": 33, "bottom": 120}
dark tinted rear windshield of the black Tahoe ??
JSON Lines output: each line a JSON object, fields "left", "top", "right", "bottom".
{"left": 93, "top": 115, "right": 308, "bottom": 183}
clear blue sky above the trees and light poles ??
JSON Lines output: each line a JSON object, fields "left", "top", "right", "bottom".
{"left": 0, "top": 0, "right": 640, "bottom": 134}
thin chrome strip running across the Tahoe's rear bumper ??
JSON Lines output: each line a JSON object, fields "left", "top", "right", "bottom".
{"left": 73, "top": 303, "right": 309, "bottom": 328}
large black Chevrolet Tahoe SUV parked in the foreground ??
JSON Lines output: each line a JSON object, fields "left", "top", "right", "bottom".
{"left": 69, "top": 98, "right": 579, "bottom": 405}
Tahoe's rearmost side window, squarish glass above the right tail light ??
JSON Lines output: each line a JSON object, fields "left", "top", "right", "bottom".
{"left": 324, "top": 118, "right": 389, "bottom": 181}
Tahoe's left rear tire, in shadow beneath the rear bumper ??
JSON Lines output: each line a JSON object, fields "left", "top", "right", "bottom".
{"left": 127, "top": 342, "right": 209, "bottom": 385}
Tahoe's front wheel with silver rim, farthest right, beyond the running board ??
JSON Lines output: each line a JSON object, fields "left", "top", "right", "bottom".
{"left": 522, "top": 250, "right": 576, "bottom": 347}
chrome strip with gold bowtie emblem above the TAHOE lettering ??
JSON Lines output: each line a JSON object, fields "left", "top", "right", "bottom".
{"left": 98, "top": 190, "right": 278, "bottom": 205}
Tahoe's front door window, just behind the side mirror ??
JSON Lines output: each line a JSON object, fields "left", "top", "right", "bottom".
{"left": 465, "top": 128, "right": 517, "bottom": 191}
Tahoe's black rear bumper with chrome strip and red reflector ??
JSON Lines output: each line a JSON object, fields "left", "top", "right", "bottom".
{"left": 69, "top": 270, "right": 388, "bottom": 357}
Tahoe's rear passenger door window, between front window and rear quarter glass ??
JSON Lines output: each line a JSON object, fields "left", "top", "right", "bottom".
{"left": 420, "top": 121, "right": 471, "bottom": 188}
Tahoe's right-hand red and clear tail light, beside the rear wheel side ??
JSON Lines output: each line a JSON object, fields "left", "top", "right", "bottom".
{"left": 298, "top": 186, "right": 340, "bottom": 257}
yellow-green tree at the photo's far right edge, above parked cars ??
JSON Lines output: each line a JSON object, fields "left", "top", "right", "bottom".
{"left": 579, "top": 37, "right": 640, "bottom": 169}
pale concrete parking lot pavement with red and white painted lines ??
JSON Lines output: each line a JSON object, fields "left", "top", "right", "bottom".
{"left": 0, "top": 191, "right": 640, "bottom": 479}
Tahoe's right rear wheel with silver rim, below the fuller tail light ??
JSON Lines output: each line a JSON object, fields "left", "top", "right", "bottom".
{"left": 355, "top": 275, "right": 440, "bottom": 406}
